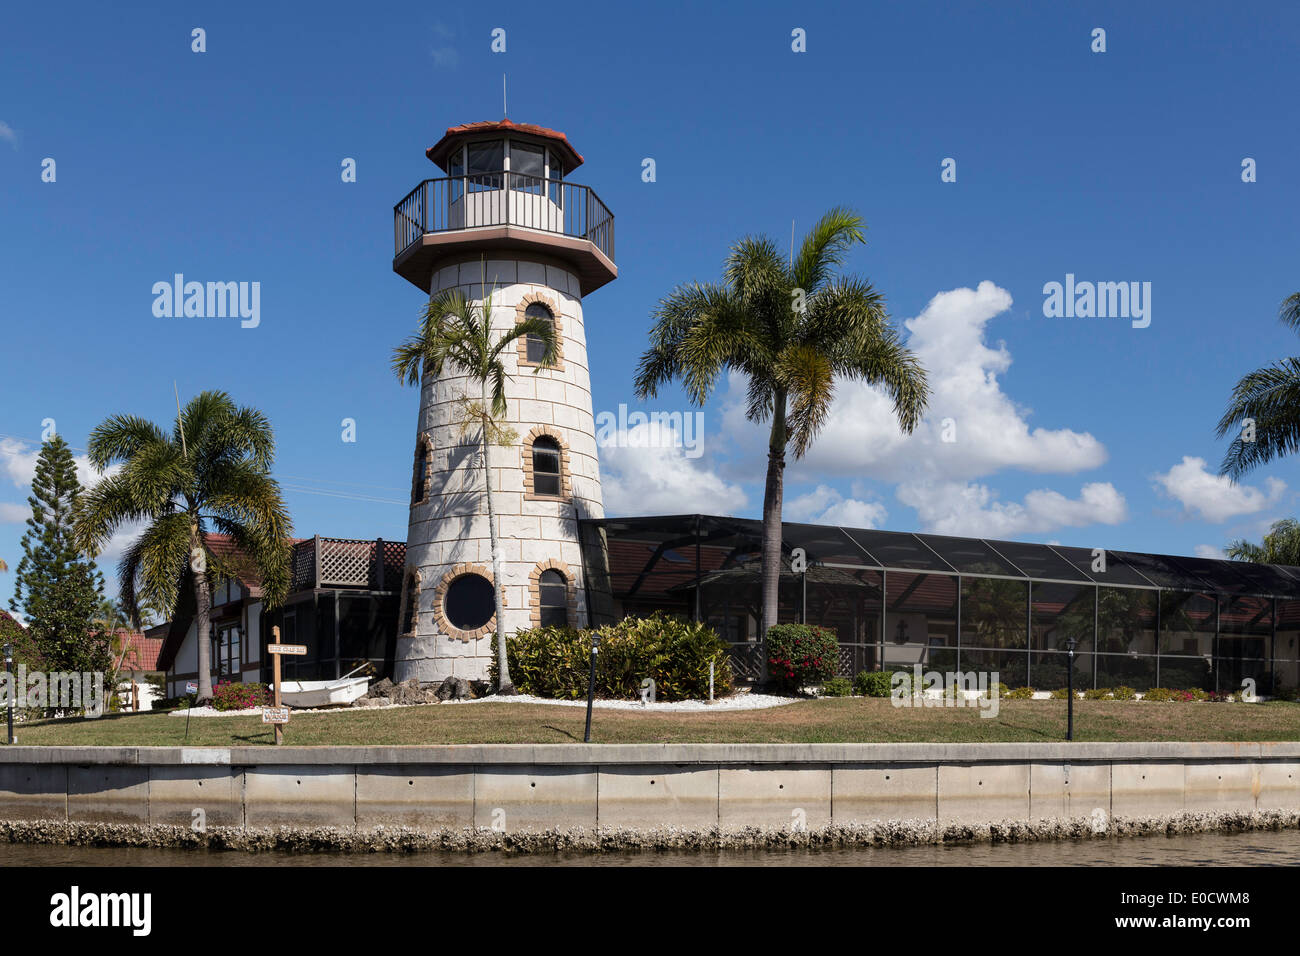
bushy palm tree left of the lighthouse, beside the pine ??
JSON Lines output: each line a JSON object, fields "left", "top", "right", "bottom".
{"left": 74, "top": 392, "right": 291, "bottom": 704}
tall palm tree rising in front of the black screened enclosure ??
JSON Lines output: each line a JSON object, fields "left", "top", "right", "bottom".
{"left": 636, "top": 208, "right": 930, "bottom": 675}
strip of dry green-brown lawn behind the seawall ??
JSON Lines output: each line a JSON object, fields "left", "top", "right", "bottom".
{"left": 16, "top": 697, "right": 1300, "bottom": 747}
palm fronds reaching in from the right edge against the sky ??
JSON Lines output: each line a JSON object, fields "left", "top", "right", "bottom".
{"left": 1216, "top": 293, "right": 1300, "bottom": 481}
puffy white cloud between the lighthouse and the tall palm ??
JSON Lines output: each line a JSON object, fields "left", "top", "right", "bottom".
{"left": 601, "top": 423, "right": 746, "bottom": 515}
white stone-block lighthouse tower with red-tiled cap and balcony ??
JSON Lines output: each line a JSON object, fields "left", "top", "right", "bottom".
{"left": 393, "top": 120, "right": 618, "bottom": 683}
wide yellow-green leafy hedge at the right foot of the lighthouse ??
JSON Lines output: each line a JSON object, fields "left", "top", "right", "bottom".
{"left": 490, "top": 611, "right": 732, "bottom": 701}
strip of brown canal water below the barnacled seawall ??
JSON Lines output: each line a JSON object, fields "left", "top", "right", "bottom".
{"left": 0, "top": 830, "right": 1300, "bottom": 868}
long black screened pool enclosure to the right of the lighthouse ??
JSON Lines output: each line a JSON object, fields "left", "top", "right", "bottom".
{"left": 584, "top": 515, "right": 1300, "bottom": 695}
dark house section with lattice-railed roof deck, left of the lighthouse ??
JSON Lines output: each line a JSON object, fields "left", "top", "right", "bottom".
{"left": 161, "top": 535, "right": 406, "bottom": 697}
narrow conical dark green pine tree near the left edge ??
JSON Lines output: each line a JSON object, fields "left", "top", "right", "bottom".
{"left": 9, "top": 436, "right": 109, "bottom": 671}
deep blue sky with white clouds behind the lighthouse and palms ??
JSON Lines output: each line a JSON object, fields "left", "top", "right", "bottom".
{"left": 0, "top": 3, "right": 1300, "bottom": 601}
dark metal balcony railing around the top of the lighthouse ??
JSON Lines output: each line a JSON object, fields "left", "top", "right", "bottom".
{"left": 393, "top": 170, "right": 614, "bottom": 260}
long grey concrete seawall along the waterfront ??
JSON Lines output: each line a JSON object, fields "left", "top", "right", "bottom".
{"left": 0, "top": 743, "right": 1300, "bottom": 839}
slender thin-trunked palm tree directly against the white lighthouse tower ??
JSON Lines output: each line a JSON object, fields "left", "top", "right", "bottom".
{"left": 393, "top": 277, "right": 556, "bottom": 695}
